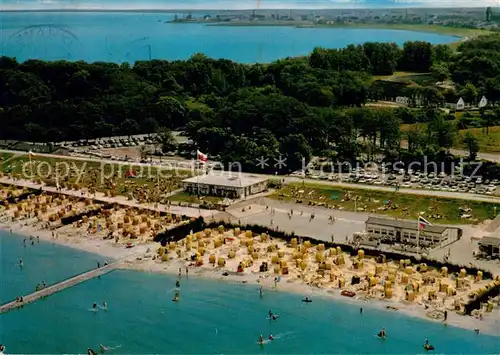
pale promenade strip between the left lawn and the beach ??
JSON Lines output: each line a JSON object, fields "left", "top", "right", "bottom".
{"left": 0, "top": 177, "right": 214, "bottom": 218}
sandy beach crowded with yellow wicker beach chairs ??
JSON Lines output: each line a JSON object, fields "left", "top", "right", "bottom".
{"left": 0, "top": 187, "right": 500, "bottom": 336}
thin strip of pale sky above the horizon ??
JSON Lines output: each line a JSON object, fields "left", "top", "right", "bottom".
{"left": 0, "top": 0, "right": 500, "bottom": 10}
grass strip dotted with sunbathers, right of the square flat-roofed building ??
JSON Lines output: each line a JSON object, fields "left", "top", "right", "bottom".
{"left": 269, "top": 183, "right": 500, "bottom": 224}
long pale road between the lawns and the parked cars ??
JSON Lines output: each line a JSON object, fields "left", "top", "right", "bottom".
{"left": 0, "top": 150, "right": 500, "bottom": 203}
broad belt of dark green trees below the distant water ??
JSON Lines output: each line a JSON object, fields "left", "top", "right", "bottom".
{"left": 0, "top": 35, "right": 500, "bottom": 174}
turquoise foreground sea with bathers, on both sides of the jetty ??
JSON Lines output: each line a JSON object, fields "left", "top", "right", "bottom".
{"left": 0, "top": 232, "right": 500, "bottom": 354}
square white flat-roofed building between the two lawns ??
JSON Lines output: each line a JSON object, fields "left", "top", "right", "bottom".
{"left": 182, "top": 172, "right": 267, "bottom": 199}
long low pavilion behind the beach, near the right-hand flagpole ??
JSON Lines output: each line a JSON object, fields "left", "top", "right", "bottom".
{"left": 365, "top": 217, "right": 462, "bottom": 246}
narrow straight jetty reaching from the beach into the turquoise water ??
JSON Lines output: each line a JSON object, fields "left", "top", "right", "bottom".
{"left": 0, "top": 259, "right": 124, "bottom": 313}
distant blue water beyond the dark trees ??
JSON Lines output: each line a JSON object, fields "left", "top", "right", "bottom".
{"left": 0, "top": 12, "right": 458, "bottom": 63}
